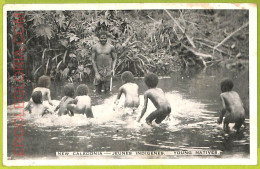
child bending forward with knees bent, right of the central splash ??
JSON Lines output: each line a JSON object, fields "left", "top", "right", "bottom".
{"left": 137, "top": 73, "right": 171, "bottom": 125}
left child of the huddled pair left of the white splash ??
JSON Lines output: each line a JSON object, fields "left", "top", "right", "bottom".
{"left": 55, "top": 84, "right": 74, "bottom": 116}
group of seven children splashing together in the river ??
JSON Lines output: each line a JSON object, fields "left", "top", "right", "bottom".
{"left": 25, "top": 71, "right": 245, "bottom": 131}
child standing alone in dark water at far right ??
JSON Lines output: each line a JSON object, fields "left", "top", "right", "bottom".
{"left": 217, "top": 79, "right": 245, "bottom": 132}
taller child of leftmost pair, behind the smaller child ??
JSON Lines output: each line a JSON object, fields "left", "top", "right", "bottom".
{"left": 24, "top": 75, "right": 53, "bottom": 112}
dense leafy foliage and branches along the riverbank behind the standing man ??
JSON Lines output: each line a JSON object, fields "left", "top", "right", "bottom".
{"left": 7, "top": 10, "right": 249, "bottom": 82}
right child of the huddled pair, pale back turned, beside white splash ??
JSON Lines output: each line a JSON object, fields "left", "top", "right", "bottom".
{"left": 67, "top": 84, "right": 94, "bottom": 118}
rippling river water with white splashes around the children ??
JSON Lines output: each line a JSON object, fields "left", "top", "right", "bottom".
{"left": 8, "top": 67, "right": 249, "bottom": 159}
